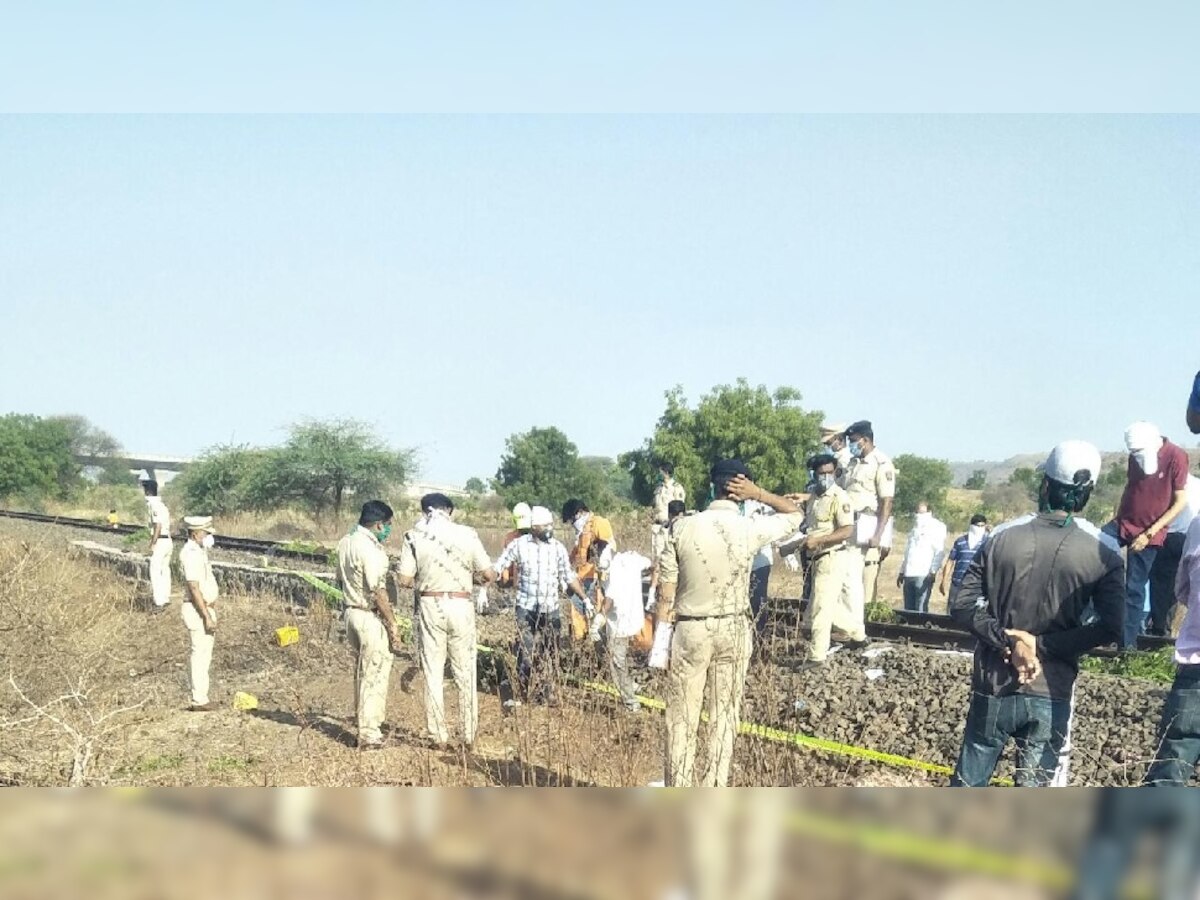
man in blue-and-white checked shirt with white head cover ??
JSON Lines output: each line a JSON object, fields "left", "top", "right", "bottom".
{"left": 492, "top": 506, "right": 590, "bottom": 706}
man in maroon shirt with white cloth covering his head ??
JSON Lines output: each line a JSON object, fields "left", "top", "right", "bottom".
{"left": 1105, "top": 422, "right": 1188, "bottom": 649}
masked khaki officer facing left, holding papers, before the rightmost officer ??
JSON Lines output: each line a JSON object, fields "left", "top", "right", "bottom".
{"left": 780, "top": 454, "right": 862, "bottom": 670}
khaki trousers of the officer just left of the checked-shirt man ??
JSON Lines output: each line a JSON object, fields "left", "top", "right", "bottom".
{"left": 418, "top": 596, "right": 479, "bottom": 744}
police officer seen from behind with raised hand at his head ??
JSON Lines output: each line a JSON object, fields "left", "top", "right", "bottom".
{"left": 655, "top": 460, "right": 804, "bottom": 787}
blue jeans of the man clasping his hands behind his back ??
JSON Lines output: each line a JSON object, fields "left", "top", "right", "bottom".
{"left": 950, "top": 692, "right": 1070, "bottom": 787}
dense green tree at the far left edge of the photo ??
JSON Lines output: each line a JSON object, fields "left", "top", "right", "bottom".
{"left": 0, "top": 414, "right": 79, "bottom": 499}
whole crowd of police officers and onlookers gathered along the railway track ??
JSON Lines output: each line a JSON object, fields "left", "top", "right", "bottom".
{"left": 138, "top": 374, "right": 1200, "bottom": 786}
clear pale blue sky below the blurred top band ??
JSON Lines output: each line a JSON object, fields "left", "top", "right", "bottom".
{"left": 0, "top": 115, "right": 1200, "bottom": 482}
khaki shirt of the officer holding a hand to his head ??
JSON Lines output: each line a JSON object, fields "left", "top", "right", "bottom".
{"left": 659, "top": 500, "right": 804, "bottom": 616}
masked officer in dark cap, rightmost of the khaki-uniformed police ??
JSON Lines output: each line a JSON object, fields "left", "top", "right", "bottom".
{"left": 842, "top": 420, "right": 896, "bottom": 641}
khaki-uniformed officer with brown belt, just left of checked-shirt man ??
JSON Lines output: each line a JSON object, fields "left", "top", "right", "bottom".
{"left": 400, "top": 493, "right": 493, "bottom": 748}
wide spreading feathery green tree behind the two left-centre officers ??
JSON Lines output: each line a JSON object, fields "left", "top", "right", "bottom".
{"left": 245, "top": 419, "right": 414, "bottom": 516}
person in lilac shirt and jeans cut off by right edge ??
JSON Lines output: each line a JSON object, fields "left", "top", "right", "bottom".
{"left": 1146, "top": 516, "right": 1200, "bottom": 802}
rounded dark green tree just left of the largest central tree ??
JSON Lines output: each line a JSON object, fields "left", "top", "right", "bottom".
{"left": 492, "top": 427, "right": 604, "bottom": 512}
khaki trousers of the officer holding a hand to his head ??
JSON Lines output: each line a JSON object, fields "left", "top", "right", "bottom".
{"left": 666, "top": 616, "right": 754, "bottom": 787}
